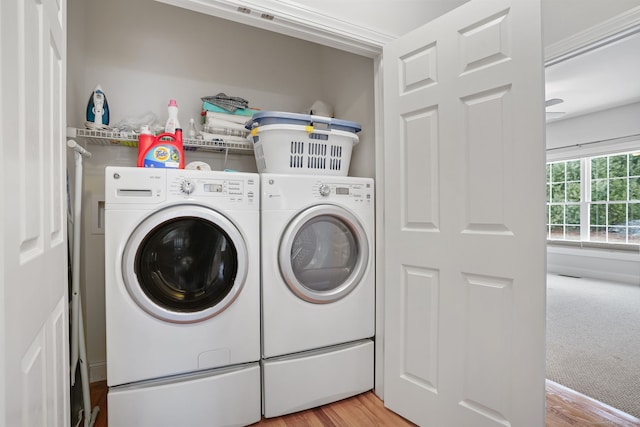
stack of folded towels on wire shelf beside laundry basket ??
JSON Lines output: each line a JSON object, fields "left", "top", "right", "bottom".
{"left": 201, "top": 93, "right": 258, "bottom": 142}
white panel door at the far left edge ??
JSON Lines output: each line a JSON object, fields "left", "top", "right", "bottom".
{"left": 0, "top": 0, "right": 70, "bottom": 427}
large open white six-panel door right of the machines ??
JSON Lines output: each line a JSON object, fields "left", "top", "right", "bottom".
{"left": 383, "top": 0, "right": 545, "bottom": 427}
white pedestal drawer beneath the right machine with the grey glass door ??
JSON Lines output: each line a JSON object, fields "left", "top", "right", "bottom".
{"left": 262, "top": 340, "right": 374, "bottom": 418}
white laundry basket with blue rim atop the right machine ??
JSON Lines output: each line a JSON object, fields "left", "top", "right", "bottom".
{"left": 247, "top": 111, "right": 360, "bottom": 176}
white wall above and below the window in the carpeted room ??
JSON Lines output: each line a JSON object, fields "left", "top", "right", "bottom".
{"left": 547, "top": 103, "right": 640, "bottom": 284}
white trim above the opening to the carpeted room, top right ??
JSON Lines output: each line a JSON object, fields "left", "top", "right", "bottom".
{"left": 544, "top": 6, "right": 640, "bottom": 66}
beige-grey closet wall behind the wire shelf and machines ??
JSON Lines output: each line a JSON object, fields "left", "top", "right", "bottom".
{"left": 67, "top": 0, "right": 375, "bottom": 381}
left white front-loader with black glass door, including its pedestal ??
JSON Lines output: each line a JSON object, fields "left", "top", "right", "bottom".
{"left": 105, "top": 167, "right": 261, "bottom": 426}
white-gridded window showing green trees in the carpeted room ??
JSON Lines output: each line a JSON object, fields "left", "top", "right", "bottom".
{"left": 547, "top": 152, "right": 640, "bottom": 244}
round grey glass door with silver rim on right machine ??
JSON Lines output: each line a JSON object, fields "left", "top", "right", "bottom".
{"left": 278, "top": 205, "right": 369, "bottom": 303}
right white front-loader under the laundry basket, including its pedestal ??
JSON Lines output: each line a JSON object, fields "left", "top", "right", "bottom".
{"left": 260, "top": 174, "right": 375, "bottom": 417}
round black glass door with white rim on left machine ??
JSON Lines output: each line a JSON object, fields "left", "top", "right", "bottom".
{"left": 122, "top": 205, "right": 248, "bottom": 323}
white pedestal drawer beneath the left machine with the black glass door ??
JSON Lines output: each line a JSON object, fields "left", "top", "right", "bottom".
{"left": 107, "top": 362, "right": 261, "bottom": 427}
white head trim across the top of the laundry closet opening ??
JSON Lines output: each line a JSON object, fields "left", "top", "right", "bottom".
{"left": 156, "top": 0, "right": 384, "bottom": 58}
